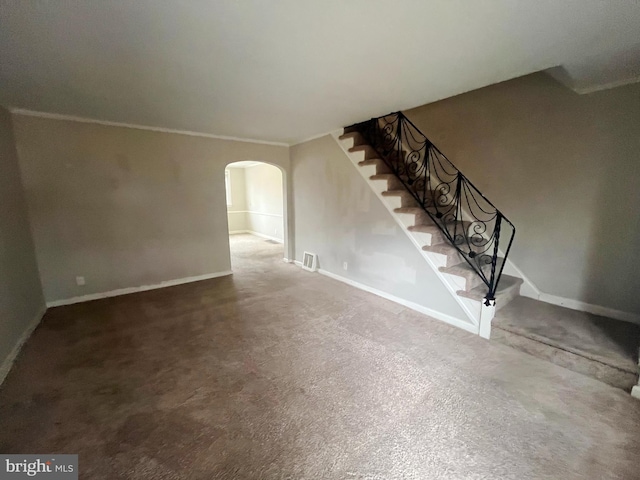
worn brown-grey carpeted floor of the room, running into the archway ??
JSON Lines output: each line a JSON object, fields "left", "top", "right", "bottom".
{"left": 0, "top": 236, "right": 640, "bottom": 480}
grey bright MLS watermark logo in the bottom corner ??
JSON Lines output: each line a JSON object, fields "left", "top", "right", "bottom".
{"left": 0, "top": 454, "right": 78, "bottom": 480}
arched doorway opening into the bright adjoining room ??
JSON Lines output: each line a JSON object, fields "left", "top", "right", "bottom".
{"left": 224, "top": 161, "right": 285, "bottom": 270}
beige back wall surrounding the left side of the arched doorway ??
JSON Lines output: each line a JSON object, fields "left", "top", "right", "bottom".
{"left": 14, "top": 115, "right": 289, "bottom": 301}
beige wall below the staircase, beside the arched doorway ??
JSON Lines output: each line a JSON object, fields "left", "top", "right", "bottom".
{"left": 291, "top": 136, "right": 467, "bottom": 321}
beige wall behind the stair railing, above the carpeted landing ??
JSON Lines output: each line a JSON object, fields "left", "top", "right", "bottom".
{"left": 406, "top": 74, "right": 640, "bottom": 313}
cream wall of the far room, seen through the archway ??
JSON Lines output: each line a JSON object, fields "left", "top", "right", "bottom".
{"left": 244, "top": 163, "right": 284, "bottom": 241}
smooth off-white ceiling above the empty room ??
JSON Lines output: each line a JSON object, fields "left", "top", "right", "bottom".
{"left": 0, "top": 0, "right": 640, "bottom": 143}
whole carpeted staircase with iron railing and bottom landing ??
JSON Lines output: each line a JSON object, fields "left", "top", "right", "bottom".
{"left": 333, "top": 112, "right": 640, "bottom": 394}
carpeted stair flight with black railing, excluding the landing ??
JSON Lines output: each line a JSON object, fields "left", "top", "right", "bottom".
{"left": 334, "top": 112, "right": 523, "bottom": 338}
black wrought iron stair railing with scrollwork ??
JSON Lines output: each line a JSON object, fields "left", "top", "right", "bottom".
{"left": 350, "top": 112, "right": 515, "bottom": 305}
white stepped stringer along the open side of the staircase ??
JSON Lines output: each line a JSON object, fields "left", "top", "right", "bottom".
{"left": 331, "top": 130, "right": 484, "bottom": 338}
